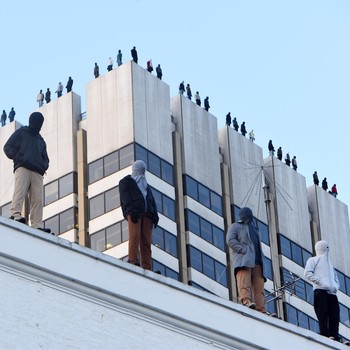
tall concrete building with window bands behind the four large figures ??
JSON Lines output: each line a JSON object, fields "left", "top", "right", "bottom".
{"left": 0, "top": 62, "right": 350, "bottom": 348}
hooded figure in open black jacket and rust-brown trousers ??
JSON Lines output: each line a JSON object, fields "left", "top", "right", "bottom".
{"left": 119, "top": 160, "right": 159, "bottom": 270}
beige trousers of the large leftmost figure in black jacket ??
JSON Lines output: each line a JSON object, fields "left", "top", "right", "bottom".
{"left": 10, "top": 167, "right": 43, "bottom": 228}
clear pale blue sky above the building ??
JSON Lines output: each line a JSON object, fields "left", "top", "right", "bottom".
{"left": 0, "top": 0, "right": 350, "bottom": 211}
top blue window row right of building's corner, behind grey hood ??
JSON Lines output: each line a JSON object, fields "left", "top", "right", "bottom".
{"left": 135, "top": 143, "right": 174, "bottom": 185}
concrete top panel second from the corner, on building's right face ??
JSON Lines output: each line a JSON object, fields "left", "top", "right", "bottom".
{"left": 171, "top": 95, "right": 222, "bottom": 195}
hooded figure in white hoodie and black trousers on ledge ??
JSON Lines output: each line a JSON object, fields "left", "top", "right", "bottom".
{"left": 304, "top": 241, "right": 340, "bottom": 341}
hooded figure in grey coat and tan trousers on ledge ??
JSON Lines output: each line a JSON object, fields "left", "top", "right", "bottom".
{"left": 226, "top": 207, "right": 266, "bottom": 313}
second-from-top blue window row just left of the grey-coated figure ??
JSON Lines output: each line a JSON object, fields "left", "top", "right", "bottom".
{"left": 185, "top": 209, "right": 225, "bottom": 251}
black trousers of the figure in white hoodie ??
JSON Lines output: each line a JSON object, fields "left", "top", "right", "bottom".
{"left": 314, "top": 289, "right": 340, "bottom": 340}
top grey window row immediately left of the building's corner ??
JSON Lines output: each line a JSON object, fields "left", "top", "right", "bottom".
{"left": 88, "top": 144, "right": 134, "bottom": 184}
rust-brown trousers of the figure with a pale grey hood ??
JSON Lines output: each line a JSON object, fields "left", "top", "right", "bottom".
{"left": 128, "top": 215, "right": 153, "bottom": 270}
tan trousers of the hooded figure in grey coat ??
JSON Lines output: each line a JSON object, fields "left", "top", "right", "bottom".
{"left": 236, "top": 265, "right": 266, "bottom": 312}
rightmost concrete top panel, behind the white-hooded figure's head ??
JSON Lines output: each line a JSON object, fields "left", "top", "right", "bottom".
{"left": 308, "top": 186, "right": 350, "bottom": 276}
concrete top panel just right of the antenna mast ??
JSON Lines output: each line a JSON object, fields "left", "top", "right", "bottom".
{"left": 264, "top": 157, "right": 312, "bottom": 251}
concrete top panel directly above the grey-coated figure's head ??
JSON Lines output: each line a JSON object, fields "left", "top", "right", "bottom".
{"left": 218, "top": 127, "right": 267, "bottom": 223}
